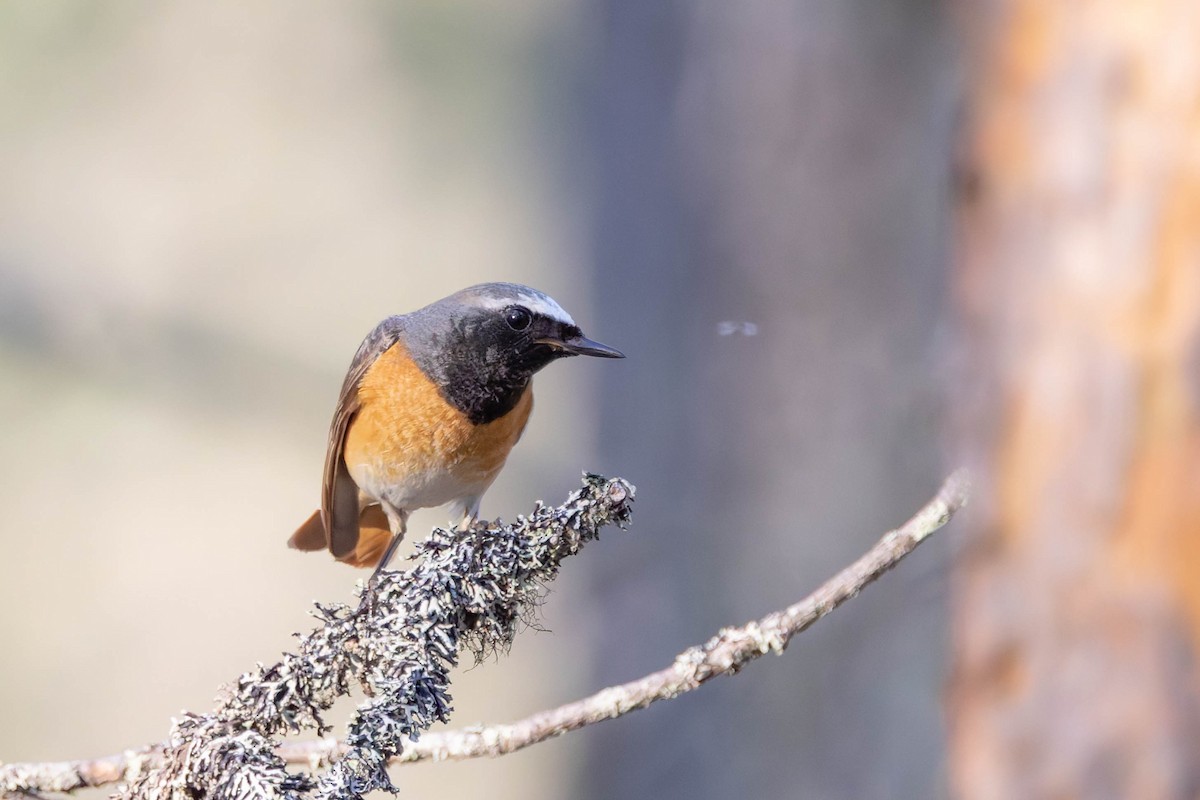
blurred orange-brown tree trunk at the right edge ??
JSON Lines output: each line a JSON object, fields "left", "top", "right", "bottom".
{"left": 950, "top": 0, "right": 1200, "bottom": 800}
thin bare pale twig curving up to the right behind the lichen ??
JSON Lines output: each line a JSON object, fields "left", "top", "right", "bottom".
{"left": 0, "top": 471, "right": 968, "bottom": 792}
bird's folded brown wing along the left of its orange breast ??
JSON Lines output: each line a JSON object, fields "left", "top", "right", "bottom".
{"left": 320, "top": 317, "right": 403, "bottom": 558}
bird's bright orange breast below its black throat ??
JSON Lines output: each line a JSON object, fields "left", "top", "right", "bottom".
{"left": 343, "top": 343, "right": 533, "bottom": 507}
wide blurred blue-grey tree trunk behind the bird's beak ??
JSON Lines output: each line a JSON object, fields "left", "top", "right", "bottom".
{"left": 575, "top": 0, "right": 954, "bottom": 799}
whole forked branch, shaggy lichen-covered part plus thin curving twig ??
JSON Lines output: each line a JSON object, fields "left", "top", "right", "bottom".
{"left": 0, "top": 471, "right": 968, "bottom": 796}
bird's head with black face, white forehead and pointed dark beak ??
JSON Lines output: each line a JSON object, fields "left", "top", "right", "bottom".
{"left": 413, "top": 287, "right": 624, "bottom": 425}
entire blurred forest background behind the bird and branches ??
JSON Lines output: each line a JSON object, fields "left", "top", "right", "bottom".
{"left": 0, "top": 0, "right": 1200, "bottom": 799}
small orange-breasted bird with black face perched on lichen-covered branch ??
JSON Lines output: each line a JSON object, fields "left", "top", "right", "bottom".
{"left": 288, "top": 283, "right": 625, "bottom": 576}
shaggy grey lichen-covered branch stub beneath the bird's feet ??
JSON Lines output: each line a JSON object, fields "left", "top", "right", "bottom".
{"left": 119, "top": 475, "right": 634, "bottom": 800}
